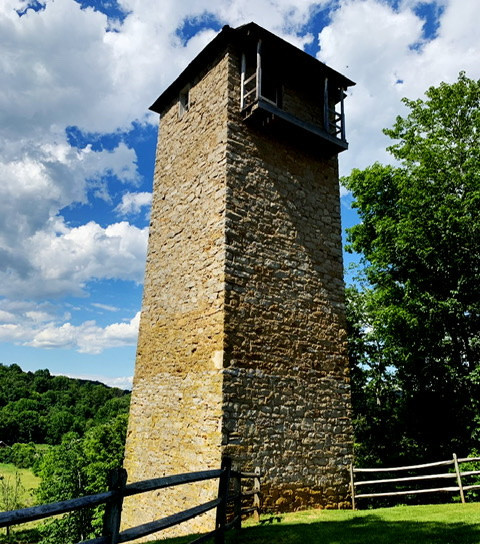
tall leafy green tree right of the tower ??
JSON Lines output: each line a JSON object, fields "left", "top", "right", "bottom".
{"left": 343, "top": 73, "right": 480, "bottom": 464}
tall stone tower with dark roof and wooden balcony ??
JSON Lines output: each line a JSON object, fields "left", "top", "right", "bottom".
{"left": 124, "top": 23, "right": 353, "bottom": 531}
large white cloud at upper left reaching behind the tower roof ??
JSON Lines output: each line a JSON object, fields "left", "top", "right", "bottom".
{"left": 0, "top": 0, "right": 328, "bottom": 137}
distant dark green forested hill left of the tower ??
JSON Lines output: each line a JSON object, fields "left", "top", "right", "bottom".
{"left": 0, "top": 364, "right": 130, "bottom": 445}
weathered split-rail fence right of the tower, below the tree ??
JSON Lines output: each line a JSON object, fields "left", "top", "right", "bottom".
{"left": 350, "top": 454, "right": 480, "bottom": 510}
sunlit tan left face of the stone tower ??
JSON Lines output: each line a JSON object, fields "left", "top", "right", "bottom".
{"left": 123, "top": 52, "right": 228, "bottom": 538}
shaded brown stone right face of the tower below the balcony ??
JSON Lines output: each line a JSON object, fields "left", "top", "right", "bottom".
{"left": 223, "top": 49, "right": 352, "bottom": 510}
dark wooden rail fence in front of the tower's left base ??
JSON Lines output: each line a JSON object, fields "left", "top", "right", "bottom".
{"left": 0, "top": 458, "right": 260, "bottom": 544}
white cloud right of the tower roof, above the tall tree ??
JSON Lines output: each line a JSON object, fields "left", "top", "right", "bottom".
{"left": 319, "top": 0, "right": 480, "bottom": 174}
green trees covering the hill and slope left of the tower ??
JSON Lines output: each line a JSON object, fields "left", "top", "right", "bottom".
{"left": 0, "top": 365, "right": 130, "bottom": 544}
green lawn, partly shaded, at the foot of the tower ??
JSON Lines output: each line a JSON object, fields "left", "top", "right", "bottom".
{"left": 150, "top": 503, "right": 480, "bottom": 544}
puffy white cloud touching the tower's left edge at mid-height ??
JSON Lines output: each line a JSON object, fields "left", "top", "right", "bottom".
{"left": 0, "top": 219, "right": 148, "bottom": 299}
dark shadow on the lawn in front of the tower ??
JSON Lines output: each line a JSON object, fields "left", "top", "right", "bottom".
{"left": 154, "top": 515, "right": 480, "bottom": 544}
